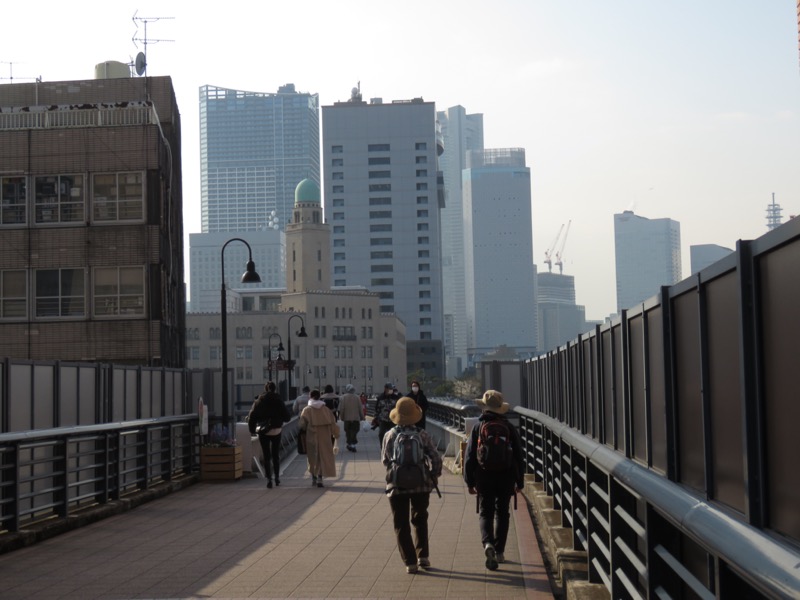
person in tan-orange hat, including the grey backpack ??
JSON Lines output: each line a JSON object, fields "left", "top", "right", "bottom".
{"left": 381, "top": 397, "right": 442, "bottom": 573}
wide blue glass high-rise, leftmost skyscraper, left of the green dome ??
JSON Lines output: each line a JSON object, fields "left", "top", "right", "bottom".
{"left": 200, "top": 83, "right": 319, "bottom": 233}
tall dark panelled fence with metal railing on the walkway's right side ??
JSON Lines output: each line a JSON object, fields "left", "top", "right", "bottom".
{"left": 484, "top": 219, "right": 800, "bottom": 598}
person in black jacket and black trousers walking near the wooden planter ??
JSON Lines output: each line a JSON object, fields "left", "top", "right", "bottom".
{"left": 247, "top": 381, "right": 292, "bottom": 488}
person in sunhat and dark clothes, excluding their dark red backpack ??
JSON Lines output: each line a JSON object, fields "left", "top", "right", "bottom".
{"left": 464, "top": 390, "right": 525, "bottom": 571}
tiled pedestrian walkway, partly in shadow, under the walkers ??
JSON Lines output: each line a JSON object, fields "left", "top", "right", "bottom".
{"left": 0, "top": 422, "right": 553, "bottom": 600}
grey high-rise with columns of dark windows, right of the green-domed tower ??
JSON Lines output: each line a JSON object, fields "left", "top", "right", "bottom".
{"left": 322, "top": 89, "right": 444, "bottom": 377}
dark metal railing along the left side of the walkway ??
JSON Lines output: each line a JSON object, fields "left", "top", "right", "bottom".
{"left": 0, "top": 415, "right": 198, "bottom": 532}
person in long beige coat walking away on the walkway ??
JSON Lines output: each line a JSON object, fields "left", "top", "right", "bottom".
{"left": 299, "top": 390, "right": 339, "bottom": 487}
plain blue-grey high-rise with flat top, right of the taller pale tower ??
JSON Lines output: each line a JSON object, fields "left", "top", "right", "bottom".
{"left": 464, "top": 148, "right": 537, "bottom": 366}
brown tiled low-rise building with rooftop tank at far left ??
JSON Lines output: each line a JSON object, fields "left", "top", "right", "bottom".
{"left": 0, "top": 74, "right": 185, "bottom": 367}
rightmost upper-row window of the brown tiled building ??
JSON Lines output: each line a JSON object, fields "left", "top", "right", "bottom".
{"left": 92, "top": 172, "right": 144, "bottom": 222}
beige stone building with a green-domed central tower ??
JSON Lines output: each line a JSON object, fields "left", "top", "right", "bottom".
{"left": 186, "top": 180, "right": 407, "bottom": 398}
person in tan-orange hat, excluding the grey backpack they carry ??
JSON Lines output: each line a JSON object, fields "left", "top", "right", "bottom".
{"left": 381, "top": 397, "right": 442, "bottom": 573}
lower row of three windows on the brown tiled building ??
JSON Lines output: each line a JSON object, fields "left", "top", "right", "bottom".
{"left": 0, "top": 267, "right": 145, "bottom": 320}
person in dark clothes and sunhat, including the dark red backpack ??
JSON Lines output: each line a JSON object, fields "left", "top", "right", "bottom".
{"left": 464, "top": 390, "right": 525, "bottom": 571}
